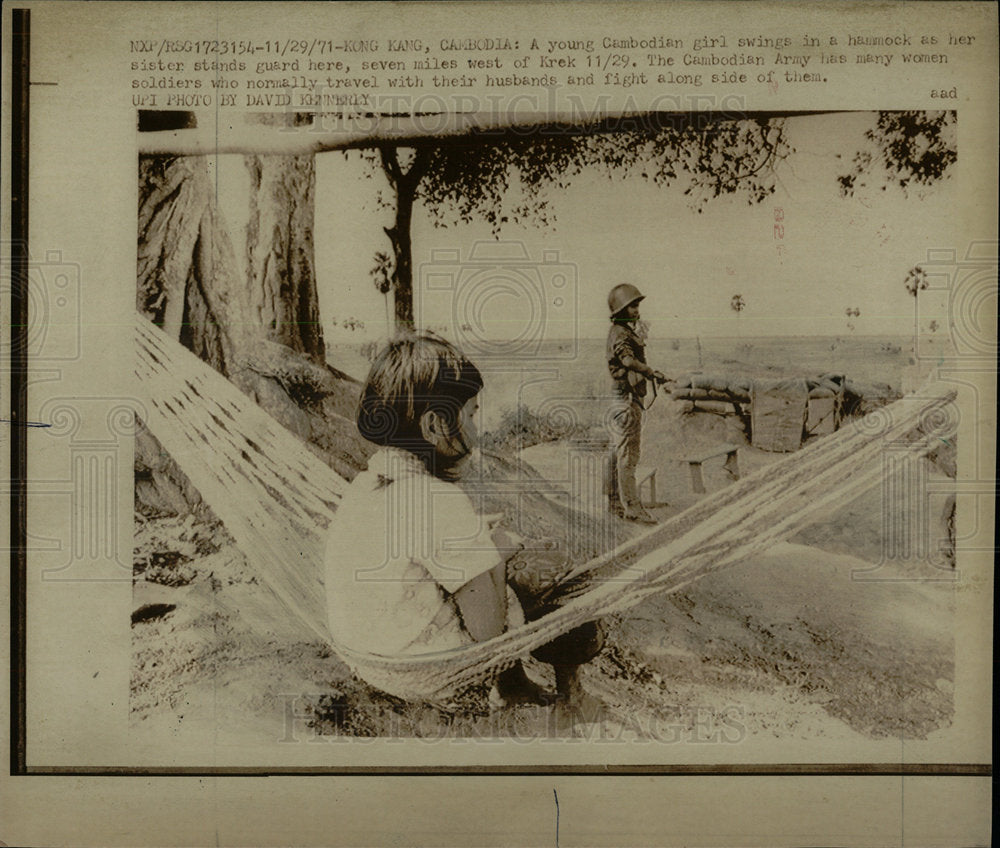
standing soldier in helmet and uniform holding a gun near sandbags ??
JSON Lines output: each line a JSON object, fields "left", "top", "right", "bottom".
{"left": 607, "top": 283, "right": 667, "bottom": 524}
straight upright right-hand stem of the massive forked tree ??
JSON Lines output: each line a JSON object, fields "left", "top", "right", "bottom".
{"left": 246, "top": 156, "right": 325, "bottom": 363}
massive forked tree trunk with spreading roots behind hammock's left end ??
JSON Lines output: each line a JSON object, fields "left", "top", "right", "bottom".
{"left": 136, "top": 150, "right": 370, "bottom": 514}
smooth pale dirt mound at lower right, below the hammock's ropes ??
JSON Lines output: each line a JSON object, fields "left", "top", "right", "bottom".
{"left": 613, "top": 544, "right": 955, "bottom": 739}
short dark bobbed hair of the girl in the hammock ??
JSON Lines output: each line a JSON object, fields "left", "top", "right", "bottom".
{"left": 358, "top": 333, "right": 483, "bottom": 452}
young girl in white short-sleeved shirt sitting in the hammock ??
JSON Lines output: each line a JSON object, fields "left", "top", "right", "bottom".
{"left": 326, "top": 334, "right": 603, "bottom": 703}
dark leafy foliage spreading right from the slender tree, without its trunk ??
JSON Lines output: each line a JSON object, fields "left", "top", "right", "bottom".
{"left": 416, "top": 118, "right": 792, "bottom": 236}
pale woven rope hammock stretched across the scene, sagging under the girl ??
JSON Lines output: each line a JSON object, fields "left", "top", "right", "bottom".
{"left": 135, "top": 318, "right": 956, "bottom": 700}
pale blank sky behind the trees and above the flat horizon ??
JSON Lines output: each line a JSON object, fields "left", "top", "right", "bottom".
{"left": 220, "top": 113, "right": 962, "bottom": 343}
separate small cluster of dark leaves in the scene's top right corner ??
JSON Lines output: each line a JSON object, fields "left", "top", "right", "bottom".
{"left": 839, "top": 111, "right": 958, "bottom": 197}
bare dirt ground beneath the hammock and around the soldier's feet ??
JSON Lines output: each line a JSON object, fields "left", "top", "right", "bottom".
{"left": 131, "top": 404, "right": 954, "bottom": 742}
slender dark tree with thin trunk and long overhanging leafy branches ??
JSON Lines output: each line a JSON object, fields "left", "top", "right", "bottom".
{"left": 352, "top": 115, "right": 793, "bottom": 326}
